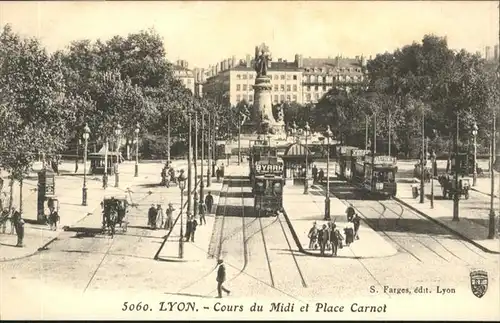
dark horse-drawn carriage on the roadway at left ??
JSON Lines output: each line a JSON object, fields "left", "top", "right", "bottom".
{"left": 101, "top": 196, "right": 129, "bottom": 236}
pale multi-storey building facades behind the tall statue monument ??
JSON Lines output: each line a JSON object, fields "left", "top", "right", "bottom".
{"left": 199, "top": 54, "right": 366, "bottom": 105}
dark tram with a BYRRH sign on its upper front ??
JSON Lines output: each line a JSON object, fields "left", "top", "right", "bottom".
{"left": 252, "top": 157, "right": 285, "bottom": 216}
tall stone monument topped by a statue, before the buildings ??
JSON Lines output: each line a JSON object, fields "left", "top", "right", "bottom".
{"left": 243, "top": 44, "right": 285, "bottom": 135}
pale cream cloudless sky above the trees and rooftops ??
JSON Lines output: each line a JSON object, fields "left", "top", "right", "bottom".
{"left": 0, "top": 1, "right": 499, "bottom": 67}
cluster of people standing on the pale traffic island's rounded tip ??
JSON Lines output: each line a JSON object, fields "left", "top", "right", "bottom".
{"left": 308, "top": 206, "right": 361, "bottom": 256}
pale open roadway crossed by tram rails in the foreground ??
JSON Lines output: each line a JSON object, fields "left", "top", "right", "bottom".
{"left": 0, "top": 162, "right": 500, "bottom": 322}
